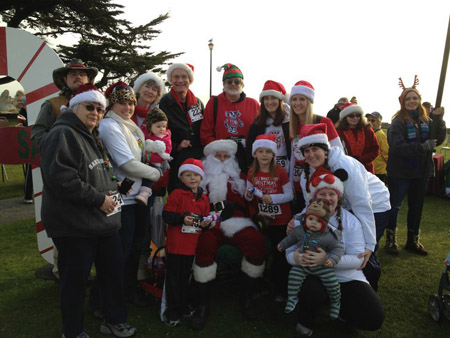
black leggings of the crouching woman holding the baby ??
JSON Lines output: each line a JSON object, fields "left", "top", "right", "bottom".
{"left": 297, "top": 276, "right": 385, "bottom": 331}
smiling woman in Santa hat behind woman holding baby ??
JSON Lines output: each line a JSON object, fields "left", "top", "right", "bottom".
{"left": 131, "top": 72, "right": 165, "bottom": 139}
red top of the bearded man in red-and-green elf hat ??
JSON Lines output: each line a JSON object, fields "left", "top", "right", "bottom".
{"left": 200, "top": 93, "right": 259, "bottom": 145}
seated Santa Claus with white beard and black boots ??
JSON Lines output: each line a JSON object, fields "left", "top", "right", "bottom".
{"left": 191, "top": 140, "right": 265, "bottom": 330}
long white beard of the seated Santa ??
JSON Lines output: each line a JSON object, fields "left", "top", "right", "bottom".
{"left": 201, "top": 155, "right": 245, "bottom": 203}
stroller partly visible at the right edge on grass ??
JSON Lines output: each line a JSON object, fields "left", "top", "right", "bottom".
{"left": 428, "top": 254, "right": 450, "bottom": 322}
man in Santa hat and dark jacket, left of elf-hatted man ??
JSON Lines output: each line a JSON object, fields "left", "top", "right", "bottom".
{"left": 159, "top": 63, "right": 204, "bottom": 192}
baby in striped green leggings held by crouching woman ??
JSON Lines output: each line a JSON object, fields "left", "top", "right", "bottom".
{"left": 278, "top": 198, "right": 344, "bottom": 319}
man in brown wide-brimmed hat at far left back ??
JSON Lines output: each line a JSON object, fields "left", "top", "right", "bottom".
{"left": 31, "top": 59, "right": 98, "bottom": 145}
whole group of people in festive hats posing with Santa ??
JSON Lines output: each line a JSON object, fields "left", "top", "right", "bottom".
{"left": 32, "top": 60, "right": 445, "bottom": 337}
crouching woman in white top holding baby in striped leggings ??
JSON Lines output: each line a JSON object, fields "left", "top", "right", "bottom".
{"left": 286, "top": 169, "right": 385, "bottom": 336}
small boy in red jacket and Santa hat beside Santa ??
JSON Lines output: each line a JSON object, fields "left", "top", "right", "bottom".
{"left": 162, "top": 158, "right": 211, "bottom": 327}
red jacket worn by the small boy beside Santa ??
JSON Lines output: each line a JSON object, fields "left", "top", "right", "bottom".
{"left": 162, "top": 188, "right": 209, "bottom": 255}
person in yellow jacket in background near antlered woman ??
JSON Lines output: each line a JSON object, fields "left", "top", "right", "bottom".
{"left": 366, "top": 111, "right": 389, "bottom": 183}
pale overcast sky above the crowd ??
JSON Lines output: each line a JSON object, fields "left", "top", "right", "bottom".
{"left": 0, "top": 0, "right": 450, "bottom": 126}
